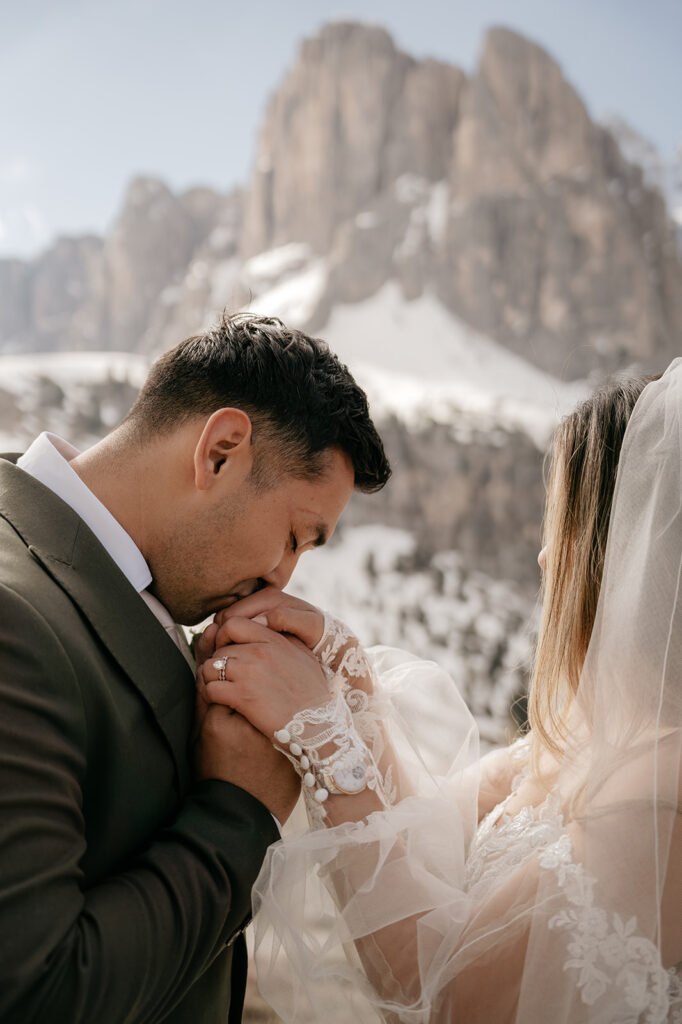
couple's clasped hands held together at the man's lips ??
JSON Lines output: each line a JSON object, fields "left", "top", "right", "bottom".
{"left": 195, "top": 587, "right": 329, "bottom": 822}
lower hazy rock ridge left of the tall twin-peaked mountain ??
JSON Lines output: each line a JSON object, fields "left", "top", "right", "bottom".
{"left": 0, "top": 178, "right": 241, "bottom": 352}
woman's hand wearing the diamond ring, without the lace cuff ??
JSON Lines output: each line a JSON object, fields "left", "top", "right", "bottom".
{"left": 197, "top": 614, "right": 329, "bottom": 739}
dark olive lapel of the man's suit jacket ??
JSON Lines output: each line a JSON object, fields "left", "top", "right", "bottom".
{"left": 0, "top": 460, "right": 195, "bottom": 792}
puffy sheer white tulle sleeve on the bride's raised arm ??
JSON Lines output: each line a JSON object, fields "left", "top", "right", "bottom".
{"left": 248, "top": 634, "right": 478, "bottom": 1022}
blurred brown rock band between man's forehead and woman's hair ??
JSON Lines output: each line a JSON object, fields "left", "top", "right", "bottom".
{"left": 344, "top": 420, "right": 545, "bottom": 593}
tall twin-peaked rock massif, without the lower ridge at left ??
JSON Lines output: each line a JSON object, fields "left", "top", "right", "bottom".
{"left": 237, "top": 25, "right": 682, "bottom": 377}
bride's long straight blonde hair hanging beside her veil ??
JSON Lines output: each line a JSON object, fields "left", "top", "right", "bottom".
{"left": 528, "top": 377, "right": 655, "bottom": 766}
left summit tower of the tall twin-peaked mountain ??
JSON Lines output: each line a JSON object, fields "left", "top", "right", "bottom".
{"left": 243, "top": 22, "right": 464, "bottom": 256}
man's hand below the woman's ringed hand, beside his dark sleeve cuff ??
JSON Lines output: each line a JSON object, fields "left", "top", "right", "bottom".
{"left": 195, "top": 695, "right": 301, "bottom": 824}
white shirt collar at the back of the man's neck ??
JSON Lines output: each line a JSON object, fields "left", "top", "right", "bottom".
{"left": 16, "top": 433, "right": 152, "bottom": 593}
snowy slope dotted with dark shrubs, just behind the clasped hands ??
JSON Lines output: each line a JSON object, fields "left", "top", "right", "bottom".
{"left": 288, "top": 525, "right": 535, "bottom": 743}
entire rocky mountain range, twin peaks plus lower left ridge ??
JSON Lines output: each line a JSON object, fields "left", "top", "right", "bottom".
{"left": 0, "top": 23, "right": 682, "bottom": 378}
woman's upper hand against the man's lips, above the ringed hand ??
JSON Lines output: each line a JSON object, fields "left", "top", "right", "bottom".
{"left": 214, "top": 587, "right": 325, "bottom": 650}
